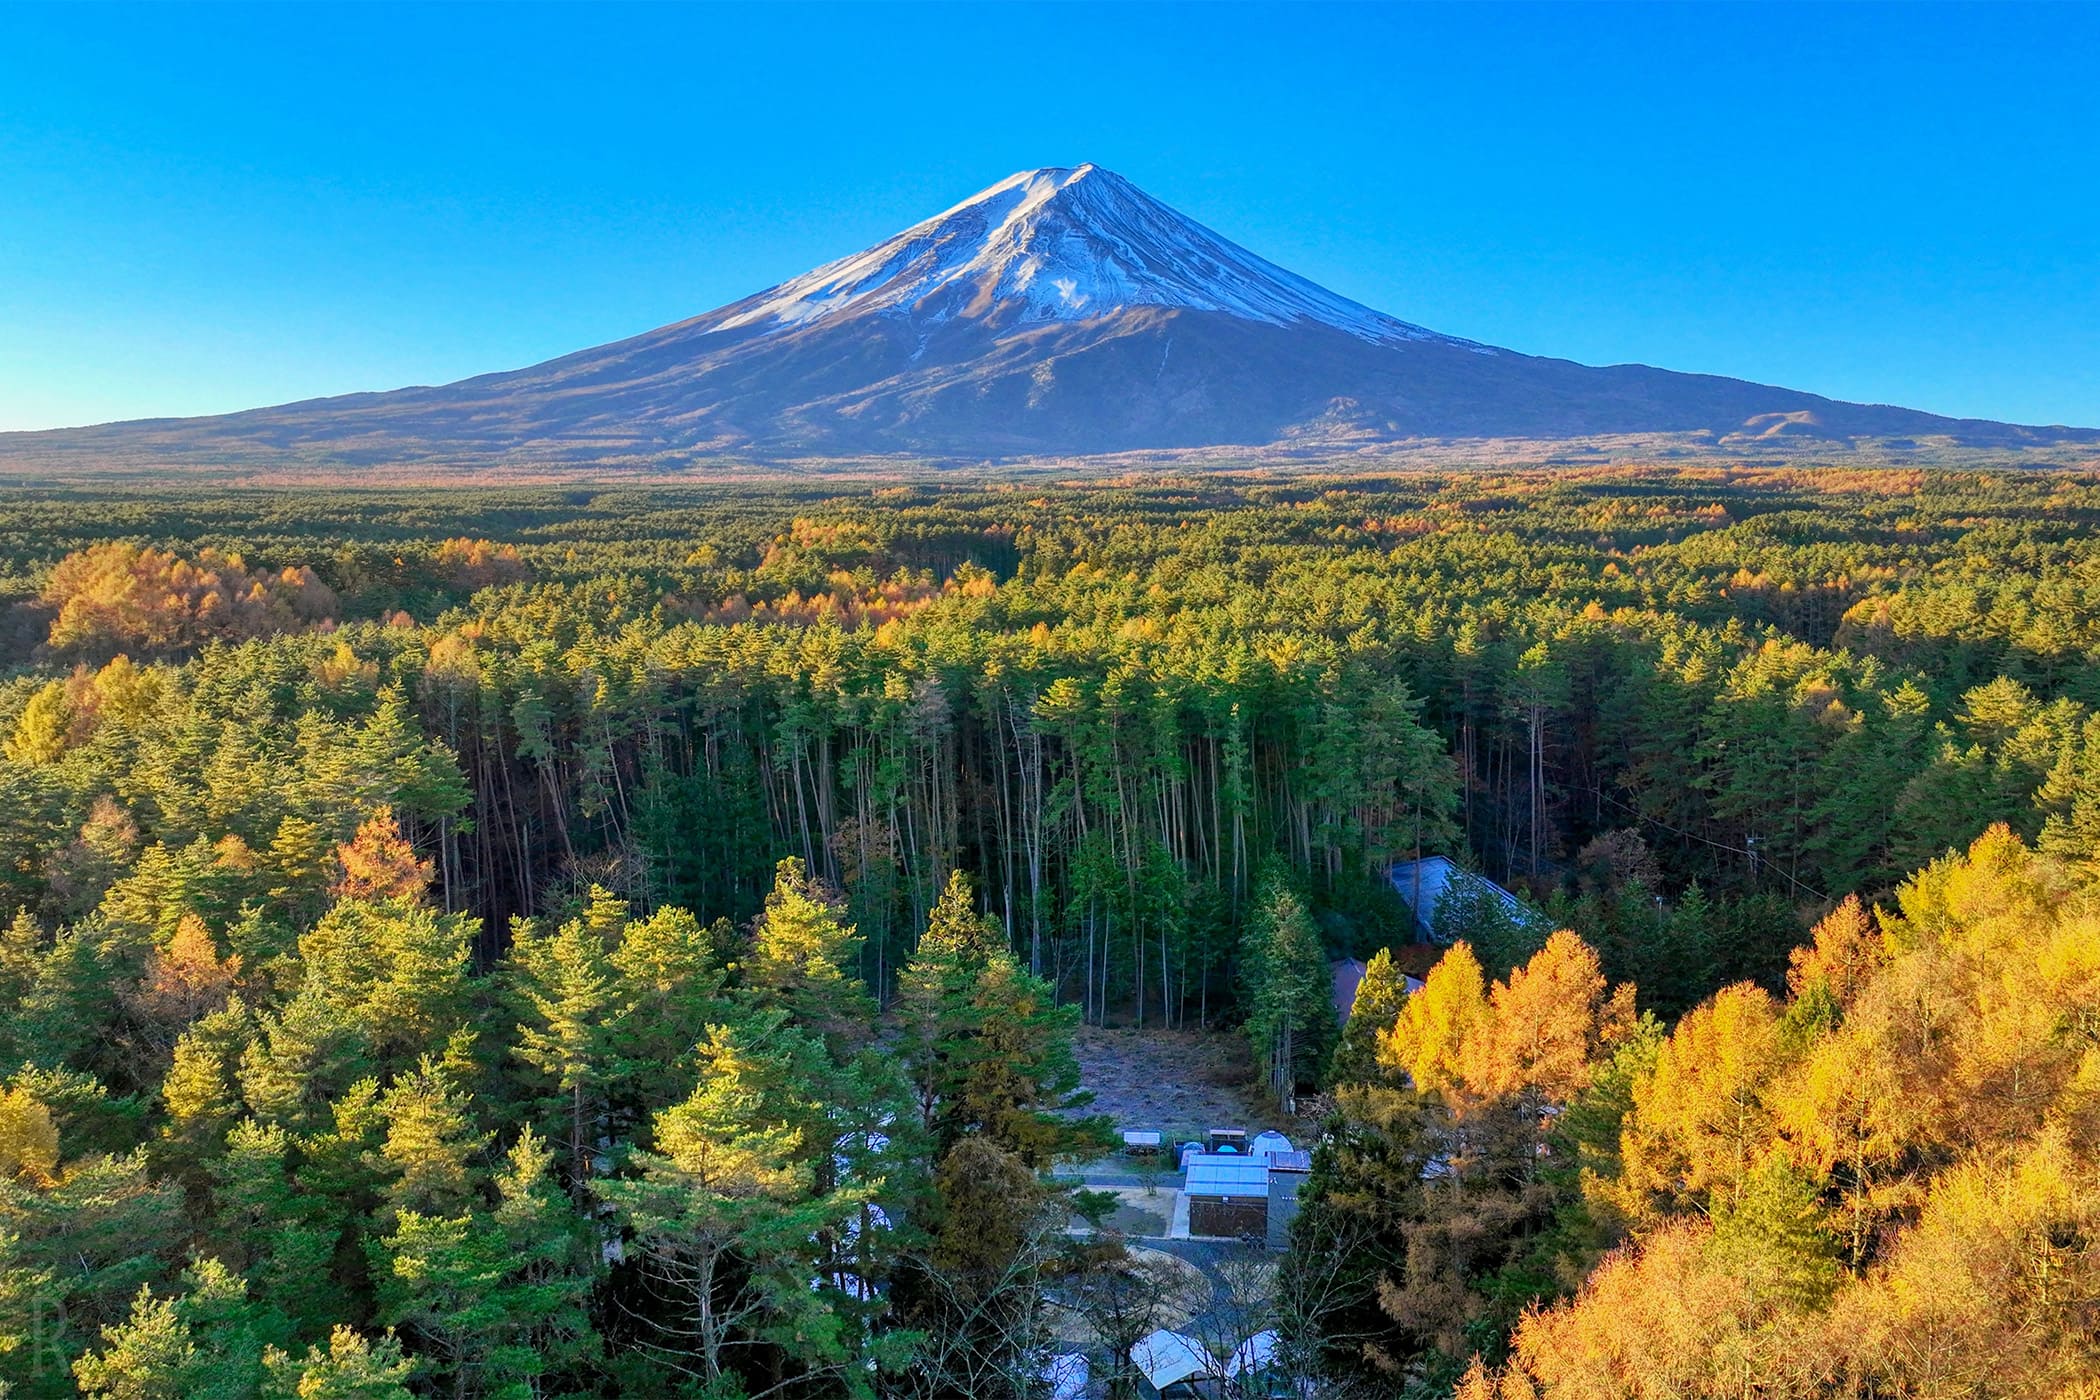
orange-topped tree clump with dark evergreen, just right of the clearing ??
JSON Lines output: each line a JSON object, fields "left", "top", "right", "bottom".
{"left": 1294, "top": 930, "right": 1638, "bottom": 1381}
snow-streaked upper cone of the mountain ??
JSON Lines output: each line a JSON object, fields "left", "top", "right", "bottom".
{"left": 710, "top": 166, "right": 1470, "bottom": 344}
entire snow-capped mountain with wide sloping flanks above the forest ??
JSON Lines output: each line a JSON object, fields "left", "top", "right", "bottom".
{"left": 0, "top": 166, "right": 2100, "bottom": 468}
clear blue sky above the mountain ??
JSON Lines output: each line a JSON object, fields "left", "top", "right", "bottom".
{"left": 0, "top": 4, "right": 2100, "bottom": 428}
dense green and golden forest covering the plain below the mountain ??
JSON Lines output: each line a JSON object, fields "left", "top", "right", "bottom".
{"left": 0, "top": 466, "right": 2100, "bottom": 1400}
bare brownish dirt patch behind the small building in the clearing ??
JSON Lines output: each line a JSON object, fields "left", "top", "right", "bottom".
{"left": 1073, "top": 1026, "right": 1292, "bottom": 1141}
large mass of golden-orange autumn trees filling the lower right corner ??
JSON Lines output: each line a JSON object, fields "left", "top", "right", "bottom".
{"left": 1460, "top": 827, "right": 2100, "bottom": 1400}
